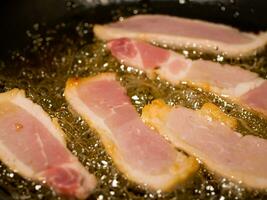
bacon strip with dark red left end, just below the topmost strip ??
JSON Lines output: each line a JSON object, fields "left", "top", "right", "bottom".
{"left": 107, "top": 38, "right": 267, "bottom": 112}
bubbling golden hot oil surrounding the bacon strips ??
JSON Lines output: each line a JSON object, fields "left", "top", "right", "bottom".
{"left": 0, "top": 3, "right": 267, "bottom": 200}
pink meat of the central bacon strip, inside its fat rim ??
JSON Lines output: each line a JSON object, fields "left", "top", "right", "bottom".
{"left": 77, "top": 80, "right": 175, "bottom": 173}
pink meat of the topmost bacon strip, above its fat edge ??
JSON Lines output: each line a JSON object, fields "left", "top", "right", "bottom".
{"left": 109, "top": 15, "right": 252, "bottom": 44}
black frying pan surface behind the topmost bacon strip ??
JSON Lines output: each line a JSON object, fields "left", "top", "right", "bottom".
{"left": 0, "top": 0, "right": 267, "bottom": 200}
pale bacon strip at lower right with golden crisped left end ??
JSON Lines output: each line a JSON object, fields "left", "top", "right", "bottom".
{"left": 142, "top": 100, "right": 267, "bottom": 189}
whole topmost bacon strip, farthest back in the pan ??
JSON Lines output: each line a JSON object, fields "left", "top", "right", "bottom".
{"left": 94, "top": 15, "right": 267, "bottom": 56}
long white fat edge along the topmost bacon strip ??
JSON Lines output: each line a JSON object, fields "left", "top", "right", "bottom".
{"left": 94, "top": 25, "right": 267, "bottom": 57}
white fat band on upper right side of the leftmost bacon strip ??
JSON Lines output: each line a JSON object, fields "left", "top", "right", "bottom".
{"left": 11, "top": 90, "right": 66, "bottom": 145}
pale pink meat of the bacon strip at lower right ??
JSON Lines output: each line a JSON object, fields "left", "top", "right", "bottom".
{"left": 166, "top": 107, "right": 267, "bottom": 187}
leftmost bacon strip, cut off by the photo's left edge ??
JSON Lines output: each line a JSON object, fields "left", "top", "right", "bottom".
{"left": 0, "top": 89, "right": 96, "bottom": 199}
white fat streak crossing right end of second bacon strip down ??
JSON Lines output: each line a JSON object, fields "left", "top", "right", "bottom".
{"left": 220, "top": 78, "right": 265, "bottom": 98}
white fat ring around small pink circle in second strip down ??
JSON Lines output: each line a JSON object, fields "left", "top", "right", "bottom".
{"left": 155, "top": 51, "right": 192, "bottom": 84}
